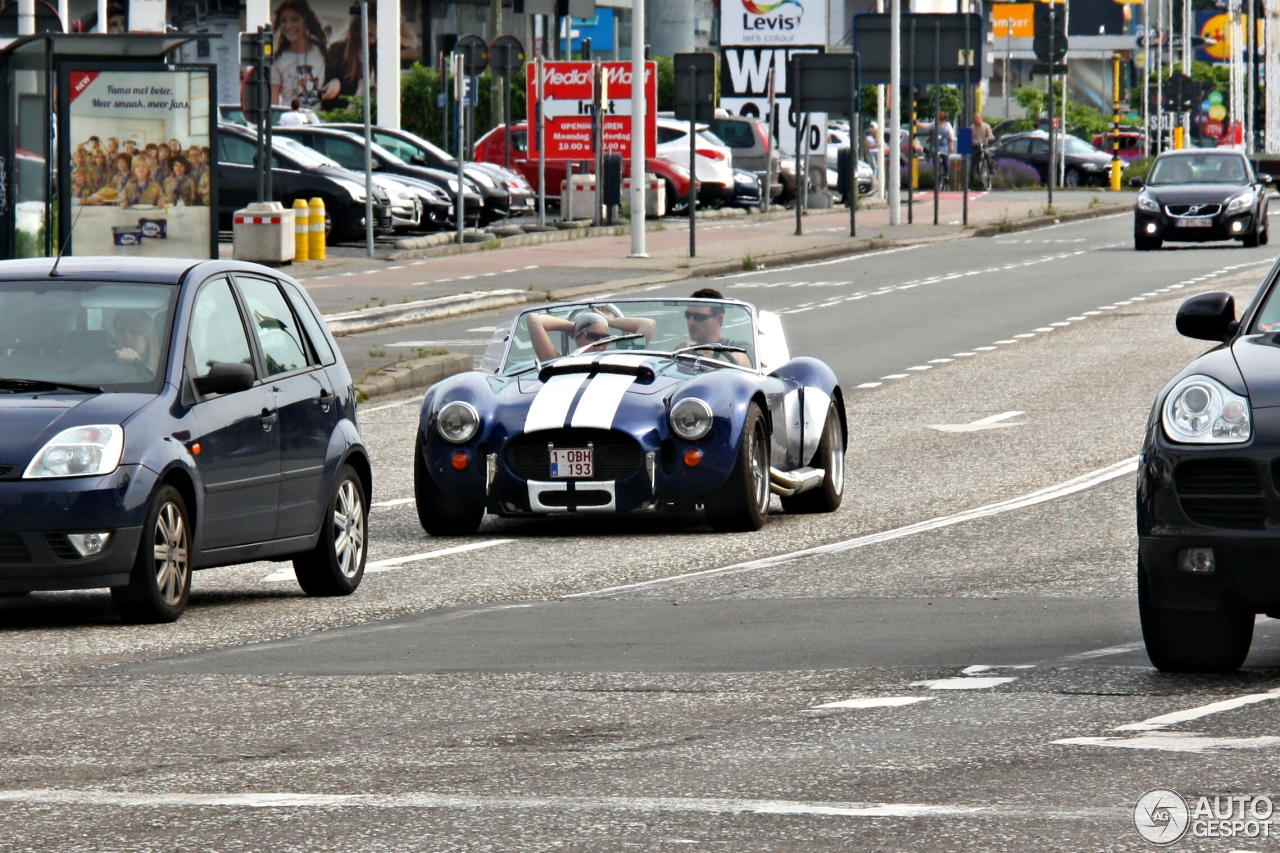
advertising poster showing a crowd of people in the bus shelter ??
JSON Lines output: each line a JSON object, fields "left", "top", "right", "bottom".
{"left": 61, "top": 65, "right": 215, "bottom": 257}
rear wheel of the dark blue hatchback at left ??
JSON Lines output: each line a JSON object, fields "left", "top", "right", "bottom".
{"left": 293, "top": 465, "right": 369, "bottom": 596}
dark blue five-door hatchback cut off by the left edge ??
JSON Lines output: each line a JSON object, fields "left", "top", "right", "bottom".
{"left": 0, "top": 257, "right": 372, "bottom": 621}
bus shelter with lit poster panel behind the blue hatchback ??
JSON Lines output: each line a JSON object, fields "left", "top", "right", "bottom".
{"left": 0, "top": 33, "right": 218, "bottom": 257}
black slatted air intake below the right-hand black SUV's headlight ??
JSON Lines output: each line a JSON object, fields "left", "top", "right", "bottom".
{"left": 1174, "top": 460, "right": 1267, "bottom": 530}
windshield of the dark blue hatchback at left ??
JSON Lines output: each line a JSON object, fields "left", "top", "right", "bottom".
{"left": 0, "top": 280, "right": 177, "bottom": 392}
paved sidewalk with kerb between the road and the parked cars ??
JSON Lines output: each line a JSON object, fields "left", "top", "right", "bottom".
{"left": 285, "top": 188, "right": 1135, "bottom": 398}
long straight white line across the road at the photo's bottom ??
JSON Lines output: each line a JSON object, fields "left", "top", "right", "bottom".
{"left": 0, "top": 788, "right": 983, "bottom": 818}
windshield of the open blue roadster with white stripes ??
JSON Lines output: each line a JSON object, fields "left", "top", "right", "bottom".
{"left": 499, "top": 300, "right": 756, "bottom": 374}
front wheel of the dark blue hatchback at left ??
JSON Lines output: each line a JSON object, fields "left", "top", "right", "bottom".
{"left": 111, "top": 485, "right": 191, "bottom": 622}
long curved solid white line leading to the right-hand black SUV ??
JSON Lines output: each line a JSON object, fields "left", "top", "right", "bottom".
{"left": 561, "top": 456, "right": 1138, "bottom": 599}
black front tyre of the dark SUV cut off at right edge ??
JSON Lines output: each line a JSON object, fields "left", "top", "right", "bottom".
{"left": 1138, "top": 561, "right": 1254, "bottom": 672}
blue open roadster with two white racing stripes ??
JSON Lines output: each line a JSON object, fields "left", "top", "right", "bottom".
{"left": 413, "top": 298, "right": 847, "bottom": 535}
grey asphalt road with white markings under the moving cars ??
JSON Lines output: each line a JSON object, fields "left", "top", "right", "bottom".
{"left": 0, "top": 220, "right": 1280, "bottom": 850}
